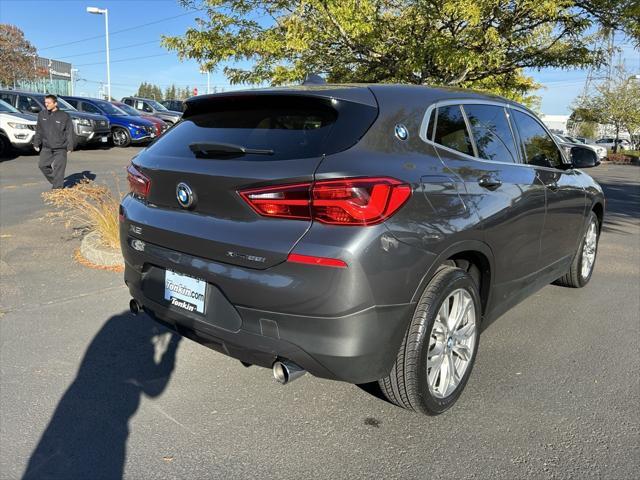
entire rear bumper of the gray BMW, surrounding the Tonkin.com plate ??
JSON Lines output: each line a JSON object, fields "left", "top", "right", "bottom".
{"left": 121, "top": 232, "right": 415, "bottom": 383}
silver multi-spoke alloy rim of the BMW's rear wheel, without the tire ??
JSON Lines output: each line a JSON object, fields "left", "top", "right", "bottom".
{"left": 427, "top": 288, "right": 477, "bottom": 398}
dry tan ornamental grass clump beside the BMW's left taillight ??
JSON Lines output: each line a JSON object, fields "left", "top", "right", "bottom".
{"left": 42, "top": 179, "right": 120, "bottom": 249}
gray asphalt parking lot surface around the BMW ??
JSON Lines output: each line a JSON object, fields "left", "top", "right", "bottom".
{"left": 0, "top": 148, "right": 640, "bottom": 479}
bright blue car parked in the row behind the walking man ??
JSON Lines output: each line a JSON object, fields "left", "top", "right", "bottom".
{"left": 62, "top": 96, "right": 156, "bottom": 147}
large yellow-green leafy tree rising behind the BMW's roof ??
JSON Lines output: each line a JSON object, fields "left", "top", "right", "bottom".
{"left": 162, "top": 0, "right": 635, "bottom": 100}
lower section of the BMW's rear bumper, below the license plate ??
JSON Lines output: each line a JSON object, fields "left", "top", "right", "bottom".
{"left": 125, "top": 264, "right": 414, "bottom": 383}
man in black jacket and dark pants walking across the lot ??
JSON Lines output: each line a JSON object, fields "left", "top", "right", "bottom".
{"left": 33, "top": 95, "right": 75, "bottom": 188}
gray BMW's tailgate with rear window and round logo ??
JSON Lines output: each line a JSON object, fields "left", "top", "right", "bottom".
{"left": 127, "top": 90, "right": 377, "bottom": 268}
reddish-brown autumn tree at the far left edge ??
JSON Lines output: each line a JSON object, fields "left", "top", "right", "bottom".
{"left": 0, "top": 23, "right": 36, "bottom": 86}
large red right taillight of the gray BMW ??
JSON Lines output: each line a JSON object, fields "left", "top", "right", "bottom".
{"left": 240, "top": 178, "right": 411, "bottom": 225}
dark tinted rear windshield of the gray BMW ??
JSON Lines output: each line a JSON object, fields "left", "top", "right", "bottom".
{"left": 149, "top": 97, "right": 377, "bottom": 161}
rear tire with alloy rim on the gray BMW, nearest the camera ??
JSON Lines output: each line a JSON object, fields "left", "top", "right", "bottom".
{"left": 378, "top": 266, "right": 482, "bottom": 415}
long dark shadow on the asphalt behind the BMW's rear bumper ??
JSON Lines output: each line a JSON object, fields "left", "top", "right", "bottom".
{"left": 23, "top": 313, "right": 181, "bottom": 479}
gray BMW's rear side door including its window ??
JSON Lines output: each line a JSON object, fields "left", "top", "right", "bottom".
{"left": 424, "top": 102, "right": 545, "bottom": 294}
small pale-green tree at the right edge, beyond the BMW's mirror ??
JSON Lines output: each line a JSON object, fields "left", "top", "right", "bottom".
{"left": 575, "top": 66, "right": 640, "bottom": 152}
